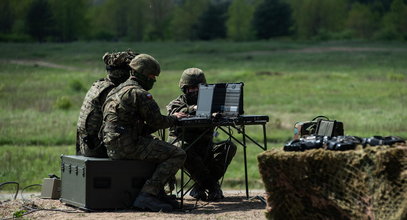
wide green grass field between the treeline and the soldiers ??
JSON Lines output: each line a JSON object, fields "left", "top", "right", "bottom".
{"left": 0, "top": 41, "right": 407, "bottom": 187}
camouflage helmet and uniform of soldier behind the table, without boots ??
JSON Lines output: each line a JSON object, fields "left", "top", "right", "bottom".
{"left": 167, "top": 68, "right": 236, "bottom": 196}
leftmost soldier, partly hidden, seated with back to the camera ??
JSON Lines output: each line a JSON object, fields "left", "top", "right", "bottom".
{"left": 76, "top": 50, "right": 137, "bottom": 157}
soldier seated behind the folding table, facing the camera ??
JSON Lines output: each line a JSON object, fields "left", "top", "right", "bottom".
{"left": 167, "top": 68, "right": 236, "bottom": 201}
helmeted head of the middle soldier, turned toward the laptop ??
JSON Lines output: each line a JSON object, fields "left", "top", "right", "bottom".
{"left": 130, "top": 54, "right": 161, "bottom": 90}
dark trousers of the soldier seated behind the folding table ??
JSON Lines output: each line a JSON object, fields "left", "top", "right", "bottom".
{"left": 171, "top": 140, "right": 237, "bottom": 189}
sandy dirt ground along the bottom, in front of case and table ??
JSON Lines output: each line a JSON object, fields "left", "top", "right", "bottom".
{"left": 0, "top": 191, "right": 265, "bottom": 220}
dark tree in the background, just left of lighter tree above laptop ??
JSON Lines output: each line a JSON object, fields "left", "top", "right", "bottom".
{"left": 197, "top": 2, "right": 229, "bottom": 40}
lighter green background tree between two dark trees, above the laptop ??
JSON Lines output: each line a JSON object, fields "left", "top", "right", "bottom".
{"left": 226, "top": 0, "right": 255, "bottom": 41}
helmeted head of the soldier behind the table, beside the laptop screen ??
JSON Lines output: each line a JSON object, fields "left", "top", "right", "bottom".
{"left": 179, "top": 68, "right": 206, "bottom": 104}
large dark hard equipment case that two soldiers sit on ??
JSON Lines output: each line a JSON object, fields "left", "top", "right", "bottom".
{"left": 60, "top": 155, "right": 156, "bottom": 210}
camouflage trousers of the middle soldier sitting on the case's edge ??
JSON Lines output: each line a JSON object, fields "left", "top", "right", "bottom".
{"left": 106, "top": 135, "right": 186, "bottom": 195}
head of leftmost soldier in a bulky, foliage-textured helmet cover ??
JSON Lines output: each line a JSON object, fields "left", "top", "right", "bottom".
{"left": 102, "top": 50, "right": 138, "bottom": 84}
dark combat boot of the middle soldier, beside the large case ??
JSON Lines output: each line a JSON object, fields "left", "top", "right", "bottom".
{"left": 133, "top": 192, "right": 172, "bottom": 212}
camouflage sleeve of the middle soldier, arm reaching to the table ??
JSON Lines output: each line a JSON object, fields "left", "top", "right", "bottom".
{"left": 137, "top": 91, "right": 177, "bottom": 129}
